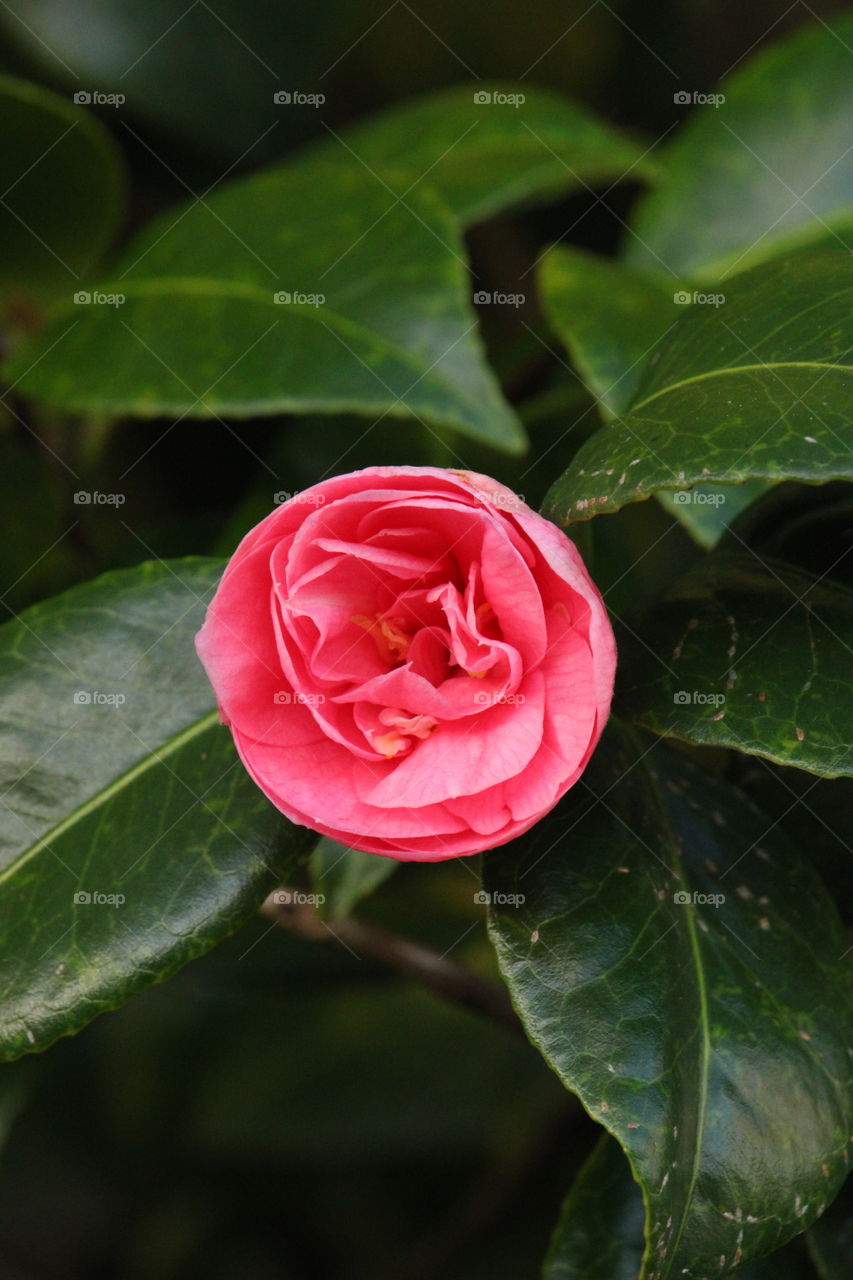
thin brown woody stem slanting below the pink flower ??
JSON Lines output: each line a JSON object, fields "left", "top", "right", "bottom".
{"left": 261, "top": 890, "right": 526, "bottom": 1038}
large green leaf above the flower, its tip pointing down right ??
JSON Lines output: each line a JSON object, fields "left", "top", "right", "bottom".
{"left": 8, "top": 146, "right": 524, "bottom": 452}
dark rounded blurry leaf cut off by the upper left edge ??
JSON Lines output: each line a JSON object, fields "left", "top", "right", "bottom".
{"left": 0, "top": 76, "right": 124, "bottom": 308}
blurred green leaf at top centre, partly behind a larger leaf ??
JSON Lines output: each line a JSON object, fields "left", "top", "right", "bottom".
{"left": 335, "top": 81, "right": 657, "bottom": 224}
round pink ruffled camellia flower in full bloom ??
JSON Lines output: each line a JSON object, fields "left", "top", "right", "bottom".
{"left": 196, "top": 467, "right": 616, "bottom": 861}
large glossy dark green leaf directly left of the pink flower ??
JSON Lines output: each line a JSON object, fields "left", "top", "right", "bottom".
{"left": 0, "top": 559, "right": 315, "bottom": 1060}
